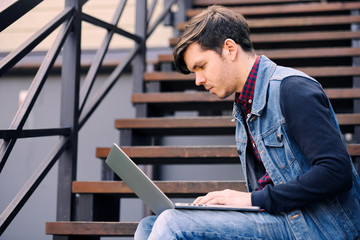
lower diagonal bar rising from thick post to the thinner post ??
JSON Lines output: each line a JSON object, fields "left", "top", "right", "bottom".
{"left": 79, "top": 46, "right": 140, "bottom": 130}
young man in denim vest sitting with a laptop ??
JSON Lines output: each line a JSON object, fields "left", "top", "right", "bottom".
{"left": 135, "top": 6, "right": 360, "bottom": 239}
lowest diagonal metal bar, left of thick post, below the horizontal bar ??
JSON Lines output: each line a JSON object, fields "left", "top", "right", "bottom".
{"left": 0, "top": 137, "right": 69, "bottom": 236}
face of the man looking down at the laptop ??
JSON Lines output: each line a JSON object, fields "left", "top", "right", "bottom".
{"left": 184, "top": 43, "right": 238, "bottom": 99}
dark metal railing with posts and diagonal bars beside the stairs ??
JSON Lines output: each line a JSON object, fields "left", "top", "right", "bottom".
{"left": 0, "top": 0, "right": 184, "bottom": 235}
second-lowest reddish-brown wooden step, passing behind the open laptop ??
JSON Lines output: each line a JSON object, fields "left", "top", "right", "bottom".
{"left": 72, "top": 181, "right": 246, "bottom": 198}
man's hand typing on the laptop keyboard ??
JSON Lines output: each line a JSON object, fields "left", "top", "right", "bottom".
{"left": 194, "top": 189, "right": 252, "bottom": 207}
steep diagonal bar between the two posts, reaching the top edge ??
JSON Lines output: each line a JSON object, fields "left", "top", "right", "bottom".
{"left": 80, "top": 0, "right": 127, "bottom": 113}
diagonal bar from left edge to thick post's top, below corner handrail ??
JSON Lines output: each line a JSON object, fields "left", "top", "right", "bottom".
{"left": 0, "top": 8, "right": 73, "bottom": 77}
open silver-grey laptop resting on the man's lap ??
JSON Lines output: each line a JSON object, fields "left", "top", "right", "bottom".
{"left": 105, "top": 143, "right": 260, "bottom": 215}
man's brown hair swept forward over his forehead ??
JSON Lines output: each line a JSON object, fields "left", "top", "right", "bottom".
{"left": 173, "top": 5, "right": 254, "bottom": 74}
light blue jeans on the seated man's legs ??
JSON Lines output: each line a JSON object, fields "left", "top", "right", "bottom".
{"left": 135, "top": 209, "right": 322, "bottom": 240}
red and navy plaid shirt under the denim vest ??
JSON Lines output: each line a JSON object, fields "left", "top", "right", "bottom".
{"left": 235, "top": 56, "right": 273, "bottom": 190}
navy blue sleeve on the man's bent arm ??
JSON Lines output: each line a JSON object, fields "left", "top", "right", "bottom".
{"left": 251, "top": 76, "right": 352, "bottom": 213}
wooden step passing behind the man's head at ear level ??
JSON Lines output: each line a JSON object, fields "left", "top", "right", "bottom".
{"left": 158, "top": 47, "right": 360, "bottom": 62}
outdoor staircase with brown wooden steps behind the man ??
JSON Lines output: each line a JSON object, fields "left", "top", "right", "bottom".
{"left": 46, "top": 0, "right": 360, "bottom": 239}
